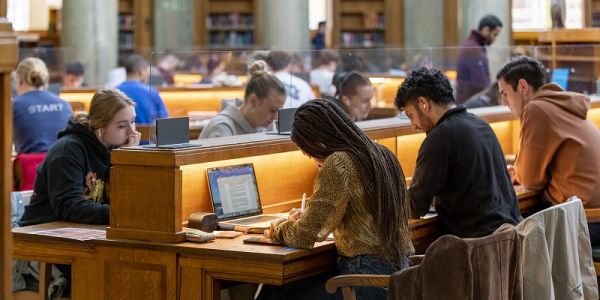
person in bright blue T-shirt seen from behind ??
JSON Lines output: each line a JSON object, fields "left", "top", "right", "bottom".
{"left": 117, "top": 54, "right": 169, "bottom": 124}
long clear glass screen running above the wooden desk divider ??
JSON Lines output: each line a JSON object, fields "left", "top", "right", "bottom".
{"left": 142, "top": 45, "right": 600, "bottom": 144}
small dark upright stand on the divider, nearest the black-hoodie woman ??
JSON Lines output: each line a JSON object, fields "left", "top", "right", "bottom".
{"left": 143, "top": 117, "right": 201, "bottom": 149}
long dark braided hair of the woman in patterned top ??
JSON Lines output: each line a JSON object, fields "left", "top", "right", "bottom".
{"left": 292, "top": 99, "right": 412, "bottom": 262}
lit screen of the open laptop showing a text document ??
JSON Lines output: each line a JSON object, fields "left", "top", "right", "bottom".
{"left": 207, "top": 164, "right": 262, "bottom": 220}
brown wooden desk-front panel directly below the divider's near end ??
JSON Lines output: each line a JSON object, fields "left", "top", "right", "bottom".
{"left": 98, "top": 247, "right": 177, "bottom": 300}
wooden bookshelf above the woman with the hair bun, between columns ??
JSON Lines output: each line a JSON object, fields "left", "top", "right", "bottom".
{"left": 195, "top": 0, "right": 260, "bottom": 50}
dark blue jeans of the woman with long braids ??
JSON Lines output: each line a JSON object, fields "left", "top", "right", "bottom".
{"left": 258, "top": 255, "right": 409, "bottom": 300}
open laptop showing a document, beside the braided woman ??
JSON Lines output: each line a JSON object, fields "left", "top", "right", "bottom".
{"left": 206, "top": 163, "right": 280, "bottom": 228}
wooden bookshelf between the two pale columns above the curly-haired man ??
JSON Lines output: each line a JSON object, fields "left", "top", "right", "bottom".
{"left": 327, "top": 0, "right": 404, "bottom": 48}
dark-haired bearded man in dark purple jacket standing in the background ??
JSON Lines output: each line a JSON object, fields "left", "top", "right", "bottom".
{"left": 456, "top": 15, "right": 502, "bottom": 104}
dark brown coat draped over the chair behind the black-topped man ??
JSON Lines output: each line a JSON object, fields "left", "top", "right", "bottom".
{"left": 388, "top": 224, "right": 523, "bottom": 299}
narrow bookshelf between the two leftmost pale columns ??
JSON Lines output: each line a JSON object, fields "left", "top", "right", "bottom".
{"left": 118, "top": 0, "right": 152, "bottom": 59}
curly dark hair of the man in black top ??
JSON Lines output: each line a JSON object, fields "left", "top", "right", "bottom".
{"left": 395, "top": 68, "right": 454, "bottom": 110}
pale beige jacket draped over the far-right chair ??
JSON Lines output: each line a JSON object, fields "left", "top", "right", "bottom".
{"left": 517, "top": 197, "right": 598, "bottom": 299}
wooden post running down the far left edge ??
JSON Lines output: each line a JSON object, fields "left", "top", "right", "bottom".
{"left": 0, "top": 16, "right": 18, "bottom": 299}
